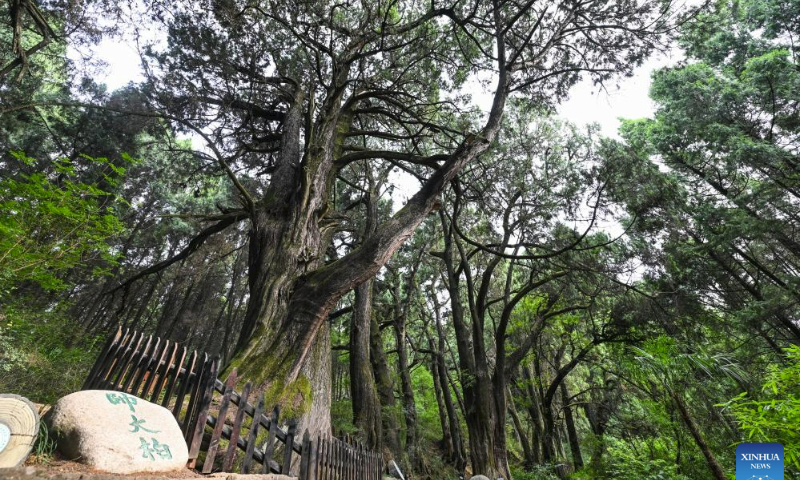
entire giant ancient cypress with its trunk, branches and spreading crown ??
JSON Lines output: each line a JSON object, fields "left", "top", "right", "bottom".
{"left": 79, "top": 0, "right": 675, "bottom": 452}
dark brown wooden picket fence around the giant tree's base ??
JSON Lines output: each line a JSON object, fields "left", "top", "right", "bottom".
{"left": 82, "top": 328, "right": 384, "bottom": 480}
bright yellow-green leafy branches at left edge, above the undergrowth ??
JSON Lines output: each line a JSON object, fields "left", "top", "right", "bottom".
{"left": 0, "top": 152, "right": 125, "bottom": 296}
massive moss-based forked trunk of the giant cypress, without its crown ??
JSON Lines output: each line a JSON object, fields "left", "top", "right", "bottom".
{"left": 231, "top": 42, "right": 510, "bottom": 436}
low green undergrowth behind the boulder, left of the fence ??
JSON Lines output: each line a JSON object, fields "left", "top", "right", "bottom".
{"left": 0, "top": 301, "right": 102, "bottom": 404}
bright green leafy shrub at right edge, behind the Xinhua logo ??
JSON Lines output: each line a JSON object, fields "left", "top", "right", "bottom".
{"left": 722, "top": 345, "right": 800, "bottom": 469}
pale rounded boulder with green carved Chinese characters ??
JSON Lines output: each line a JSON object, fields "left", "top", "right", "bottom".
{"left": 45, "top": 390, "right": 189, "bottom": 473}
